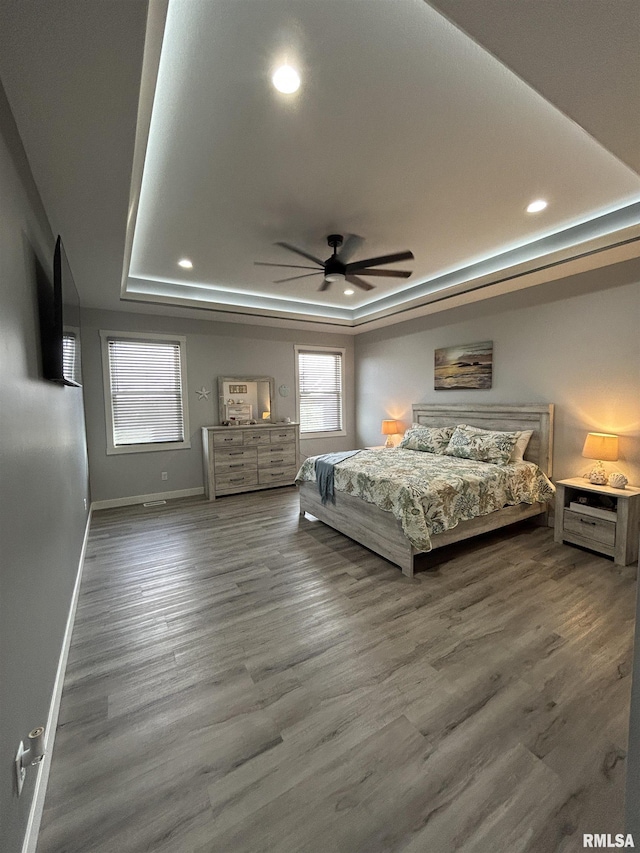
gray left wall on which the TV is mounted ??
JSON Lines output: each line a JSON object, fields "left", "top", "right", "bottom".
{"left": 0, "top": 86, "right": 89, "bottom": 853}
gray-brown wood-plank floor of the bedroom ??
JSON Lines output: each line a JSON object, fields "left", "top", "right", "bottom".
{"left": 38, "top": 488, "right": 635, "bottom": 853}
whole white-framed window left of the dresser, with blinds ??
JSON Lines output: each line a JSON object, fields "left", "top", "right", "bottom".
{"left": 100, "top": 332, "right": 191, "bottom": 453}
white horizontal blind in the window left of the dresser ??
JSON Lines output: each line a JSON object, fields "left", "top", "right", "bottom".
{"left": 108, "top": 340, "right": 184, "bottom": 446}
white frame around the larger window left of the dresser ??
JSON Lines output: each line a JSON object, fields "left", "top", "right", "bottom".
{"left": 100, "top": 329, "right": 191, "bottom": 456}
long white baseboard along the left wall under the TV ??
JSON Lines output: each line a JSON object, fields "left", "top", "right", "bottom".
{"left": 22, "top": 509, "right": 91, "bottom": 853}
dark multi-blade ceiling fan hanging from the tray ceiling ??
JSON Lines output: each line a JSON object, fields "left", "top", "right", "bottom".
{"left": 254, "top": 234, "right": 413, "bottom": 290}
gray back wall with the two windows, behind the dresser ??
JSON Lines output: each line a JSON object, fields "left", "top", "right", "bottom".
{"left": 82, "top": 310, "right": 355, "bottom": 501}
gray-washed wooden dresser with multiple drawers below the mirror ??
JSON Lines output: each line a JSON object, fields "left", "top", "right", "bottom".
{"left": 202, "top": 424, "right": 300, "bottom": 501}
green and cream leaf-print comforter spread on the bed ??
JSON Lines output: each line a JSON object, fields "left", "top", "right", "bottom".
{"left": 296, "top": 448, "right": 555, "bottom": 551}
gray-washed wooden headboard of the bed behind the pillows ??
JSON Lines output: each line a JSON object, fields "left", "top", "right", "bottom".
{"left": 412, "top": 403, "right": 553, "bottom": 477}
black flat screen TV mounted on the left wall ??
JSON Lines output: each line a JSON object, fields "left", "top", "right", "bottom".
{"left": 42, "top": 237, "right": 82, "bottom": 387}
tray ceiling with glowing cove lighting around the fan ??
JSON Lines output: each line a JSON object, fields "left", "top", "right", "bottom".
{"left": 0, "top": 0, "right": 640, "bottom": 331}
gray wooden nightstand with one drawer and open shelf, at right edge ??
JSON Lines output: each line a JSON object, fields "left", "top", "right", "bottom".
{"left": 554, "top": 477, "right": 640, "bottom": 566}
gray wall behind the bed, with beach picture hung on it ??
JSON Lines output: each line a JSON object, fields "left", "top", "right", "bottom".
{"left": 355, "top": 261, "right": 640, "bottom": 485}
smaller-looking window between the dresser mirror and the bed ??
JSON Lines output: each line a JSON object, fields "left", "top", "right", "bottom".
{"left": 295, "top": 346, "right": 345, "bottom": 438}
